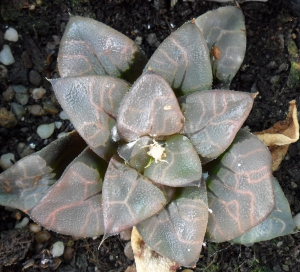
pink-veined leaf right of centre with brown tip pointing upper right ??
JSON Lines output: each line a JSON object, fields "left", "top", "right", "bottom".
{"left": 180, "top": 90, "right": 253, "bottom": 162}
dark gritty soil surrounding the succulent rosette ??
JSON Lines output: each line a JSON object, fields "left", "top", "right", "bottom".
{"left": 0, "top": 0, "right": 300, "bottom": 271}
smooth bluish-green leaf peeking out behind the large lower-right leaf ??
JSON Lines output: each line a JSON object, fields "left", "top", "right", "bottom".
{"left": 231, "top": 177, "right": 296, "bottom": 244}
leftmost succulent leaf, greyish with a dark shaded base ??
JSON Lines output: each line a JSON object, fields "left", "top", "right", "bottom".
{"left": 0, "top": 132, "right": 86, "bottom": 212}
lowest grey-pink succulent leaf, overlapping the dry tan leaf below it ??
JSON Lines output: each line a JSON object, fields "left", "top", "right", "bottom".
{"left": 136, "top": 184, "right": 208, "bottom": 266}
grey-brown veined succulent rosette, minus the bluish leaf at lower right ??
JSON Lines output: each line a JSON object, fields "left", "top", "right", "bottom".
{"left": 0, "top": 7, "right": 296, "bottom": 266}
